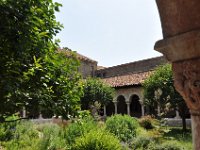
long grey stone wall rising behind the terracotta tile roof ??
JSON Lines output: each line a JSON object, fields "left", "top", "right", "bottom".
{"left": 96, "top": 56, "right": 167, "bottom": 78}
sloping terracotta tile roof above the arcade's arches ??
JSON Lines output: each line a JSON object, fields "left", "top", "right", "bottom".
{"left": 102, "top": 71, "right": 153, "bottom": 87}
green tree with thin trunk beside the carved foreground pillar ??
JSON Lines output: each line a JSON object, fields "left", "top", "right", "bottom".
{"left": 143, "top": 64, "right": 188, "bottom": 130}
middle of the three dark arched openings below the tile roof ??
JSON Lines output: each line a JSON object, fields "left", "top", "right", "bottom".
{"left": 117, "top": 95, "right": 127, "bottom": 114}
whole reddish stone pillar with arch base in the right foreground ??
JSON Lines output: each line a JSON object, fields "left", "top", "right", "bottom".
{"left": 155, "top": 0, "right": 200, "bottom": 150}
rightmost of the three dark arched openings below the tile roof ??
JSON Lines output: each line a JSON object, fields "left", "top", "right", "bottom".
{"left": 130, "top": 95, "right": 142, "bottom": 118}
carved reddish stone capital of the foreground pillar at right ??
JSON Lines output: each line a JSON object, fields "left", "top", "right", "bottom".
{"left": 172, "top": 58, "right": 200, "bottom": 112}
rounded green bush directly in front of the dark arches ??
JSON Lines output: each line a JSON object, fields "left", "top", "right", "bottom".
{"left": 106, "top": 115, "right": 139, "bottom": 142}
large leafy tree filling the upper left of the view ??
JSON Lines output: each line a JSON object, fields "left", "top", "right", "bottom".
{"left": 0, "top": 0, "right": 81, "bottom": 122}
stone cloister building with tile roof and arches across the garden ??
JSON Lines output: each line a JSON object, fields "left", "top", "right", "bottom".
{"left": 77, "top": 54, "right": 167, "bottom": 117}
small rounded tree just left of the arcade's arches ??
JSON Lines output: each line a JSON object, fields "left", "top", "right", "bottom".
{"left": 81, "top": 78, "right": 114, "bottom": 113}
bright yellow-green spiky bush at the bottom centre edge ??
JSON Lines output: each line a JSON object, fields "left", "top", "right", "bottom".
{"left": 71, "top": 129, "right": 122, "bottom": 150}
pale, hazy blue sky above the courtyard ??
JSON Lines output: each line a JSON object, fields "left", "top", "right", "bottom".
{"left": 56, "top": 0, "right": 162, "bottom": 67}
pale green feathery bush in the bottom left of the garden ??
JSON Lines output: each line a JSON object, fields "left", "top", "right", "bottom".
{"left": 3, "top": 121, "right": 68, "bottom": 150}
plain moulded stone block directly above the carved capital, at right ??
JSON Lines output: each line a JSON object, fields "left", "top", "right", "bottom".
{"left": 154, "top": 30, "right": 200, "bottom": 62}
